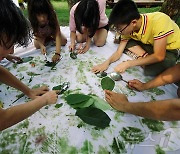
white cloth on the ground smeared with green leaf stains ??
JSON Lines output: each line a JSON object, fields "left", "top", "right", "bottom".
{"left": 0, "top": 27, "right": 180, "bottom": 154}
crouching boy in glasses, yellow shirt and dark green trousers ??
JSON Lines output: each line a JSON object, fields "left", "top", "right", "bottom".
{"left": 92, "top": 0, "right": 180, "bottom": 76}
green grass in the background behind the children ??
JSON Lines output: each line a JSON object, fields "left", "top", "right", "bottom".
{"left": 23, "top": 0, "right": 180, "bottom": 26}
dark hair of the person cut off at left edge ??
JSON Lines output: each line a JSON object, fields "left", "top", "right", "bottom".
{"left": 0, "top": 0, "right": 31, "bottom": 49}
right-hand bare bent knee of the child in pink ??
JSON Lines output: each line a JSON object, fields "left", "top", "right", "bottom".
{"left": 93, "top": 28, "right": 108, "bottom": 47}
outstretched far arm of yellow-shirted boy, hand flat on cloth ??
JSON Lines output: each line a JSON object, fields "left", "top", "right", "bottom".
{"left": 92, "top": 41, "right": 128, "bottom": 73}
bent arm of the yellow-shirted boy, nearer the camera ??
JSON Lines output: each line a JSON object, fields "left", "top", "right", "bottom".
{"left": 114, "top": 37, "right": 167, "bottom": 72}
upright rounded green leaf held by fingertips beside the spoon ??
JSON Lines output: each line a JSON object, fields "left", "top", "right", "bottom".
{"left": 101, "top": 77, "right": 115, "bottom": 90}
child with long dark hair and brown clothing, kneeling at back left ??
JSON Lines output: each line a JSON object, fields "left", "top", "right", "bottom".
{"left": 28, "top": 0, "right": 67, "bottom": 62}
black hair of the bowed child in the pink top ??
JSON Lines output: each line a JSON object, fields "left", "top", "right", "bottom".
{"left": 74, "top": 0, "right": 100, "bottom": 37}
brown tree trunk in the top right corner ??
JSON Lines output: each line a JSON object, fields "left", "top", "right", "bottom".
{"left": 160, "top": 0, "right": 180, "bottom": 21}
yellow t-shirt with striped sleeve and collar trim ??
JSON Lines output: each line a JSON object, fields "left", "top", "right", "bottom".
{"left": 121, "top": 12, "right": 180, "bottom": 50}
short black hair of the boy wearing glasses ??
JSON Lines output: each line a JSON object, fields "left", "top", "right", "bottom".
{"left": 109, "top": 0, "right": 140, "bottom": 25}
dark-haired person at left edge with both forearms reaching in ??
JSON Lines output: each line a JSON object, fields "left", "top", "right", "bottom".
{"left": 0, "top": 0, "right": 57, "bottom": 131}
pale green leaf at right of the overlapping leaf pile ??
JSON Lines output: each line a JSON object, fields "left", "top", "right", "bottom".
{"left": 91, "top": 96, "right": 112, "bottom": 111}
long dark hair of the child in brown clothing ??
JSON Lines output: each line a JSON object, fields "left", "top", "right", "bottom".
{"left": 28, "top": 0, "right": 59, "bottom": 34}
